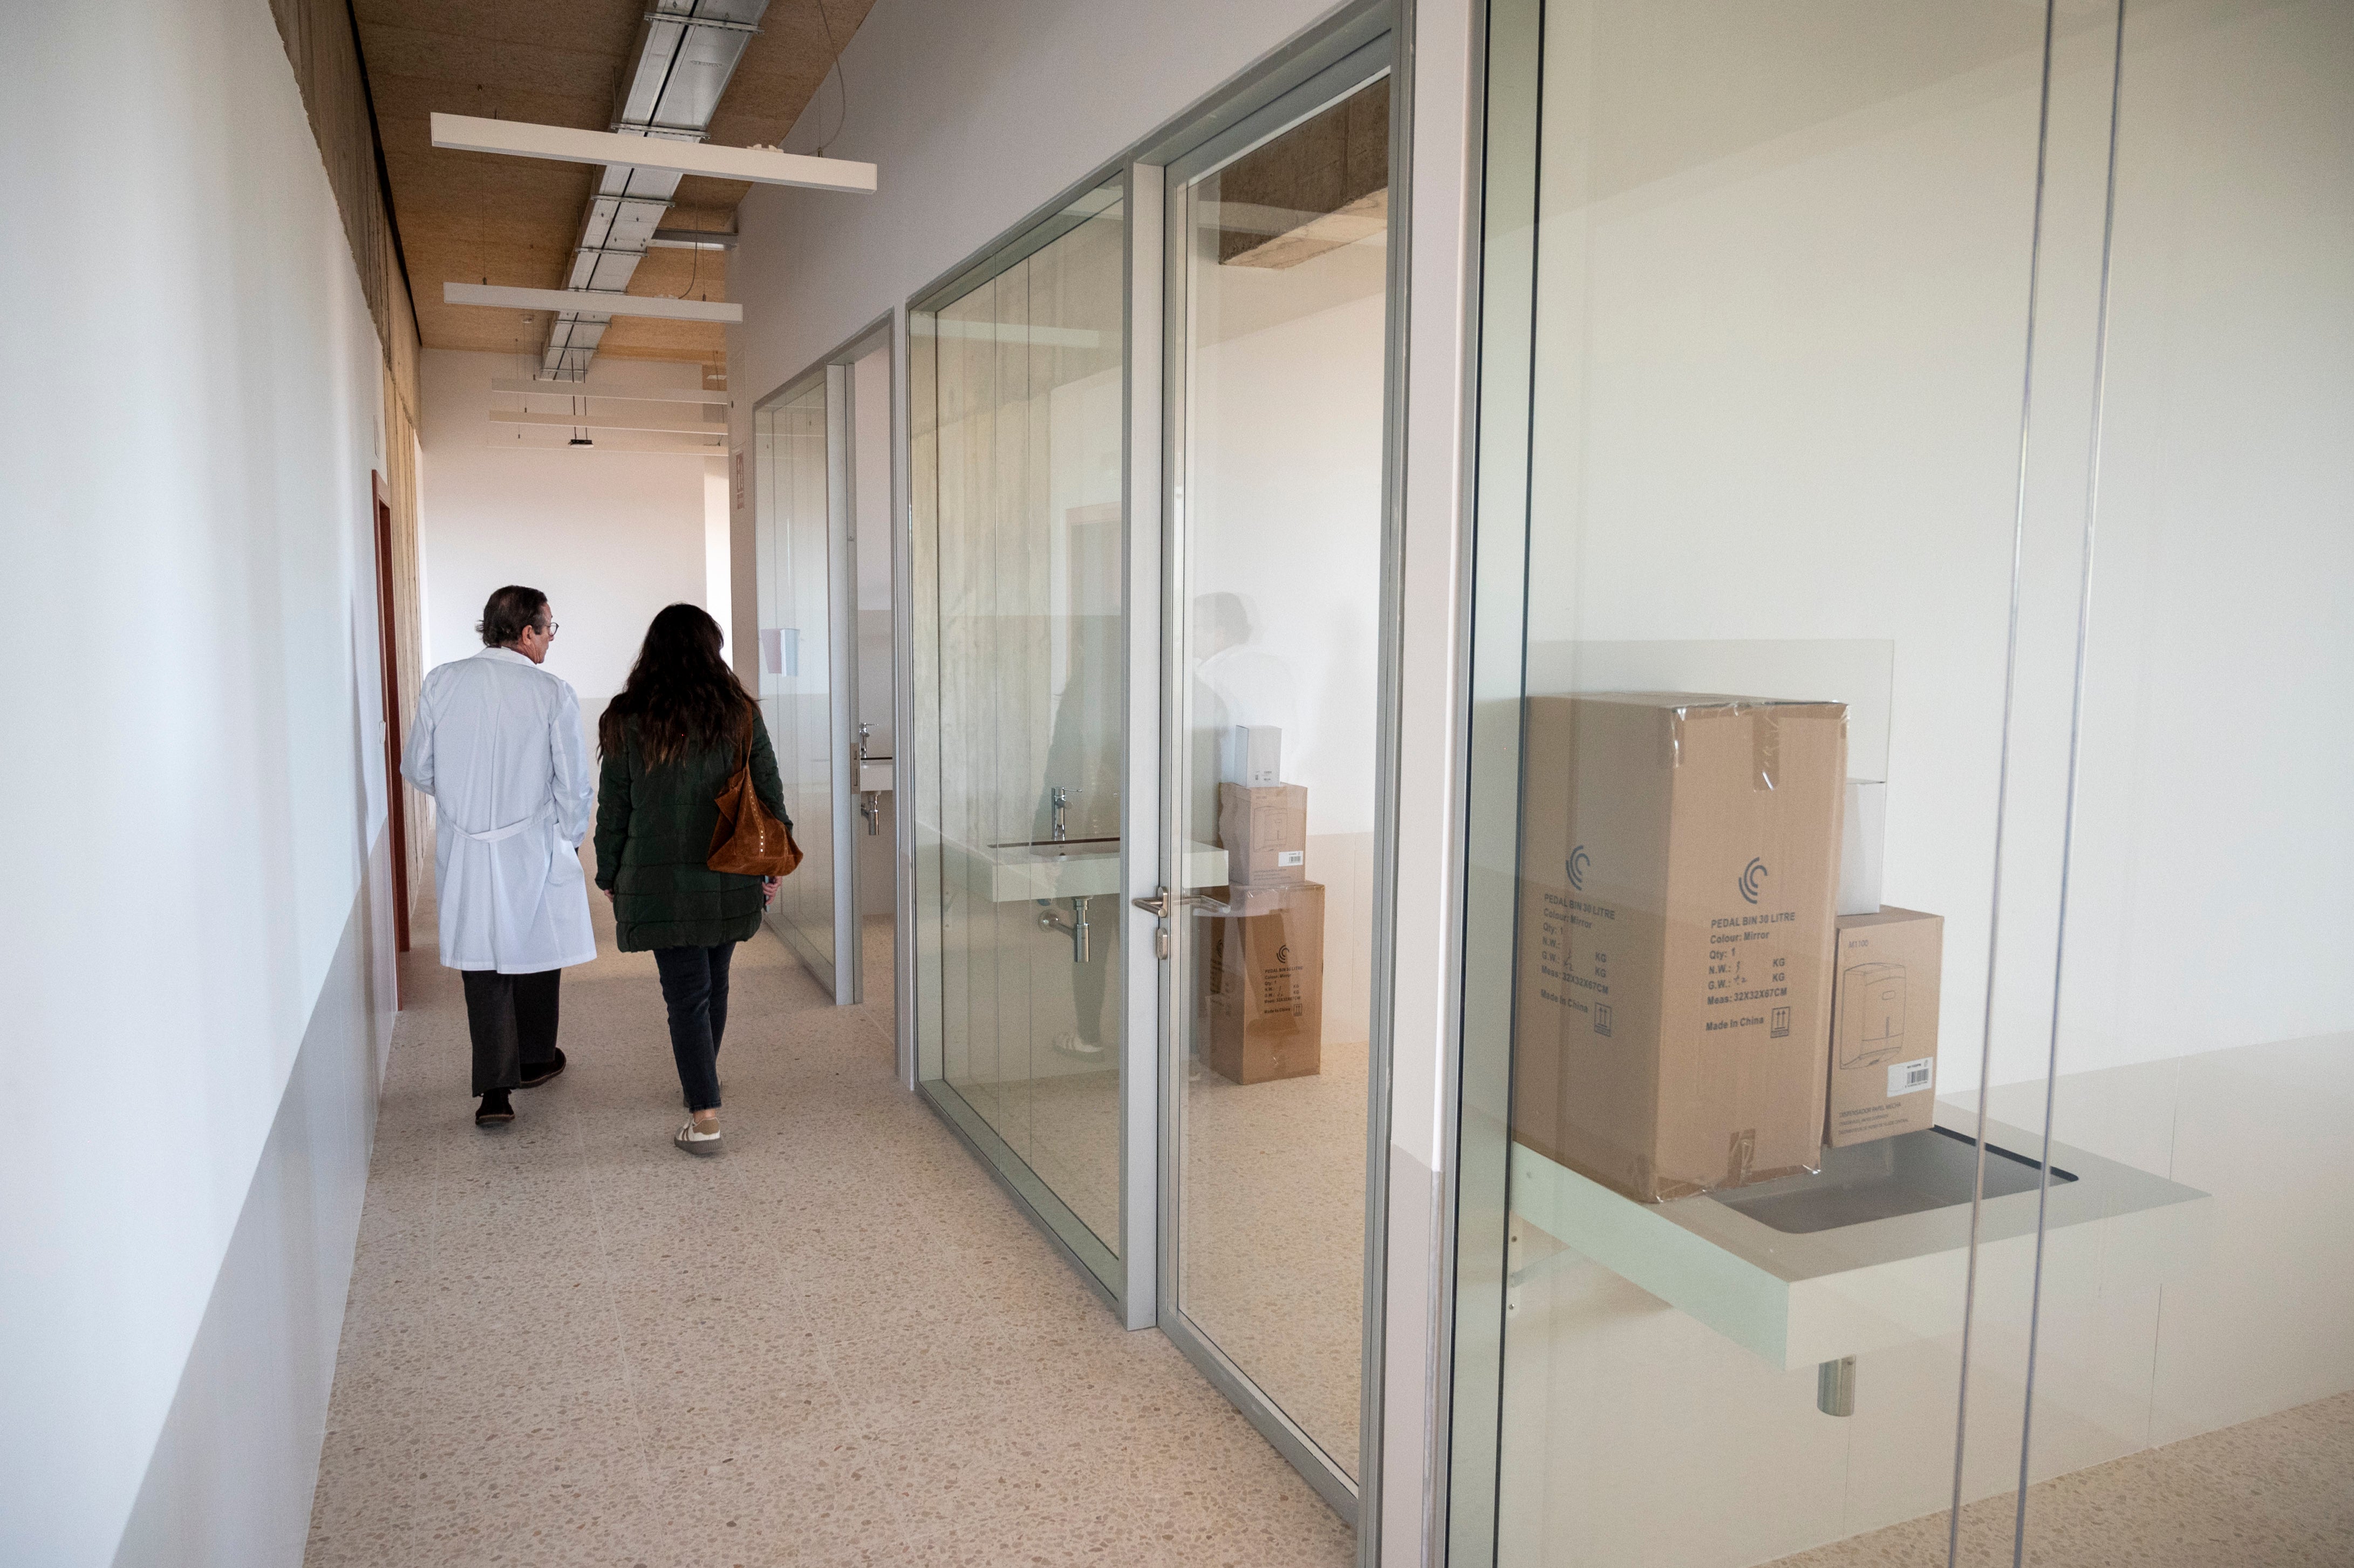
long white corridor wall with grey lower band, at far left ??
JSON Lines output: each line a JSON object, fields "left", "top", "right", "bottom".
{"left": 0, "top": 0, "right": 388, "bottom": 1566}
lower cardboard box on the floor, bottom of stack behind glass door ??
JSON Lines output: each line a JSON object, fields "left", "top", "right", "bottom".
{"left": 1203, "top": 883, "right": 1323, "bottom": 1083}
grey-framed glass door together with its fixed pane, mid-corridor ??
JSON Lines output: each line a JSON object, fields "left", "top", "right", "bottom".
{"left": 897, "top": 14, "right": 1396, "bottom": 1521}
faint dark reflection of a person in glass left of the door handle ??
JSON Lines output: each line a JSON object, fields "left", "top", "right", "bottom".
{"left": 1031, "top": 615, "right": 1123, "bottom": 1062}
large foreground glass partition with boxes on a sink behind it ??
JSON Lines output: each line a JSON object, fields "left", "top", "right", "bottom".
{"left": 1448, "top": 0, "right": 2354, "bottom": 1568}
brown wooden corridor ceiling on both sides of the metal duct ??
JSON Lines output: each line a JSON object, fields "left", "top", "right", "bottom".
{"left": 353, "top": 0, "right": 874, "bottom": 365}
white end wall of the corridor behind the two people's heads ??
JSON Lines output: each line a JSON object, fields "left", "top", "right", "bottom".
{"left": 417, "top": 349, "right": 727, "bottom": 734}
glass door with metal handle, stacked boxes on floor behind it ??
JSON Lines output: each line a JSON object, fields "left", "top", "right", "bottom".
{"left": 1163, "top": 64, "right": 1391, "bottom": 1514}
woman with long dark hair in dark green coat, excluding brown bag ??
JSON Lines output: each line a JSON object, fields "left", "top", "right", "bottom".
{"left": 596, "top": 605, "right": 791, "bottom": 1154}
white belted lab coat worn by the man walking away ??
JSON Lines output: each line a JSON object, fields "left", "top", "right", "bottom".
{"left": 400, "top": 647, "right": 596, "bottom": 974}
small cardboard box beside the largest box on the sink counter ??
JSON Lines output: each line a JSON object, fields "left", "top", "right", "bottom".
{"left": 1822, "top": 906, "right": 1944, "bottom": 1149}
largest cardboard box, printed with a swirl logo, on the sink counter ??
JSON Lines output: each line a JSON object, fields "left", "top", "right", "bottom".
{"left": 1511, "top": 692, "right": 1848, "bottom": 1203}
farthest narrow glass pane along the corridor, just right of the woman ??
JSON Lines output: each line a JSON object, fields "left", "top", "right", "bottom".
{"left": 753, "top": 367, "right": 857, "bottom": 1003}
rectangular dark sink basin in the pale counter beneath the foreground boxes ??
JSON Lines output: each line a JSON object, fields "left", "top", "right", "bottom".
{"left": 1709, "top": 1128, "right": 2076, "bottom": 1236}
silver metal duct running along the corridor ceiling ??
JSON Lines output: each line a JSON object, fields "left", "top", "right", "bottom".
{"left": 539, "top": 0, "right": 767, "bottom": 381}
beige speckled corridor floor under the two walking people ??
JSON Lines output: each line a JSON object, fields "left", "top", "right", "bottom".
{"left": 306, "top": 899, "right": 1354, "bottom": 1568}
